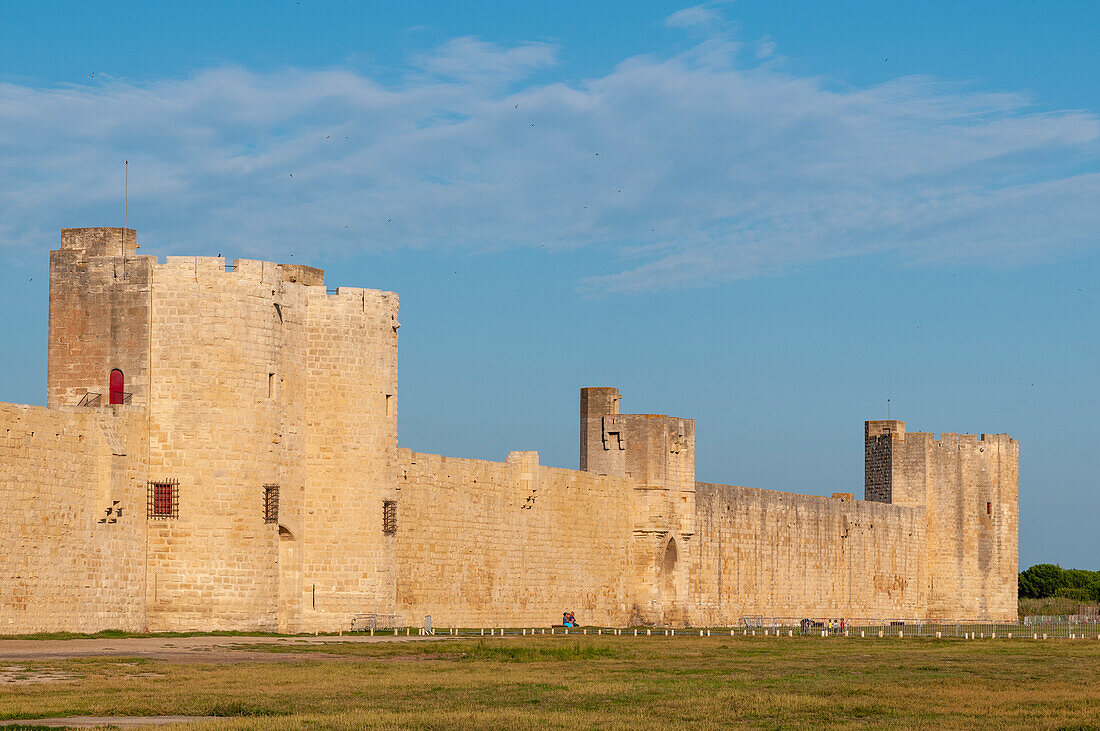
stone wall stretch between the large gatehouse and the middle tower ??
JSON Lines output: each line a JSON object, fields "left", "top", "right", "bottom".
{"left": 397, "top": 450, "right": 635, "bottom": 627}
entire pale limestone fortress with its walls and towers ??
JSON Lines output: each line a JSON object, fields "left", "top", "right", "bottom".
{"left": 0, "top": 228, "right": 1019, "bottom": 634}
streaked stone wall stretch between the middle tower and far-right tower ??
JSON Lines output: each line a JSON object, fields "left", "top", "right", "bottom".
{"left": 691, "top": 483, "right": 925, "bottom": 624}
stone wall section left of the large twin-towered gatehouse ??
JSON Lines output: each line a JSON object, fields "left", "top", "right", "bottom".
{"left": 0, "top": 403, "right": 145, "bottom": 634}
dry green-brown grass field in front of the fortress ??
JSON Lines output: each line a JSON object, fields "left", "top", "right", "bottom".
{"left": 0, "top": 635, "right": 1100, "bottom": 729}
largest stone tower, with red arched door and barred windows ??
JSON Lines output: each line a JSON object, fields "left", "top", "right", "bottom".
{"left": 47, "top": 229, "right": 398, "bottom": 631}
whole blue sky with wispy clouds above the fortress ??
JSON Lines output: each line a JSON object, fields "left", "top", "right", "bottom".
{"left": 0, "top": 0, "right": 1100, "bottom": 568}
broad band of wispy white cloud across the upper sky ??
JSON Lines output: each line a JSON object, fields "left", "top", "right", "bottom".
{"left": 0, "top": 16, "right": 1100, "bottom": 292}
